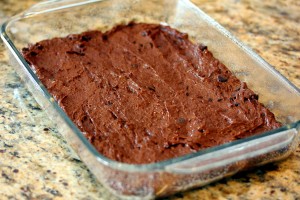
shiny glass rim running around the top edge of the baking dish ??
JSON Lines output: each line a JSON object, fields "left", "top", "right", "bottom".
{"left": 0, "top": 0, "right": 300, "bottom": 172}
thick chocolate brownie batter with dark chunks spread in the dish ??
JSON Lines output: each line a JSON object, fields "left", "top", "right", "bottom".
{"left": 22, "top": 23, "right": 280, "bottom": 164}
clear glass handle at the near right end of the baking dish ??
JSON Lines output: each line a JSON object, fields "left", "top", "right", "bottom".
{"left": 166, "top": 126, "right": 300, "bottom": 174}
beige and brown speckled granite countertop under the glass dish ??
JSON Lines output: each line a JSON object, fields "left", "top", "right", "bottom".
{"left": 0, "top": 0, "right": 300, "bottom": 199}
